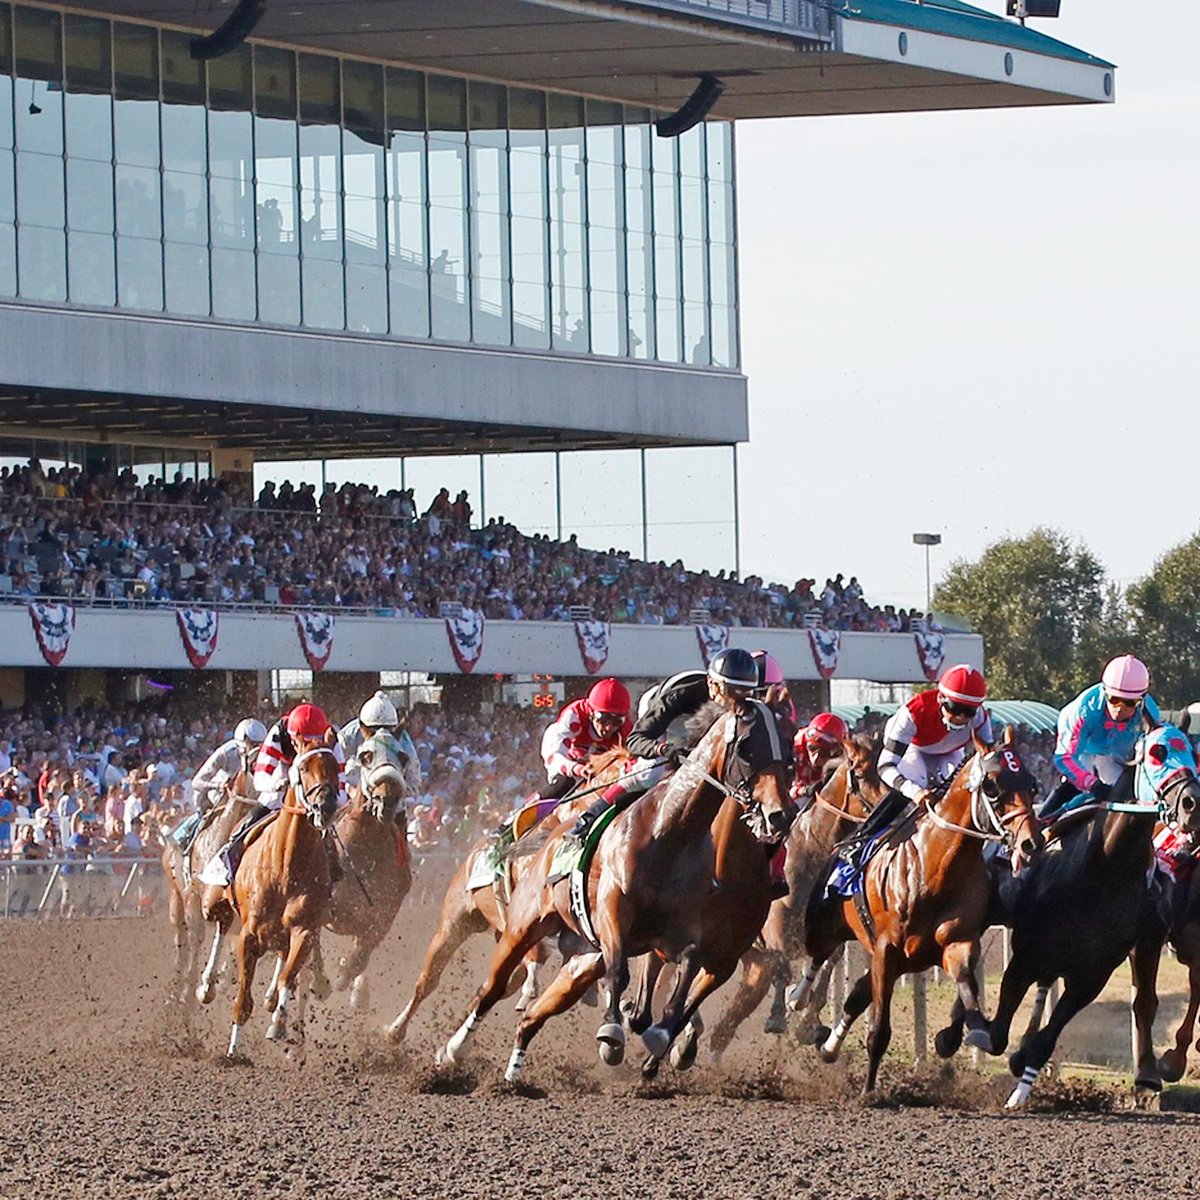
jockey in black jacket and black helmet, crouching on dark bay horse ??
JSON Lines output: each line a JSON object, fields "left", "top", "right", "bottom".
{"left": 568, "top": 647, "right": 758, "bottom": 840}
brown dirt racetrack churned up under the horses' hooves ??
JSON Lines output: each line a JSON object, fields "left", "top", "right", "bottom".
{"left": 0, "top": 883, "right": 1200, "bottom": 1200}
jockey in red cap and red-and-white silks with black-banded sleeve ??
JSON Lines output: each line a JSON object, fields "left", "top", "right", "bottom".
{"left": 842, "top": 662, "right": 995, "bottom": 865}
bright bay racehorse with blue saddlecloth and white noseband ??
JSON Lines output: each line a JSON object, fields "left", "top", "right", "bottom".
{"left": 802, "top": 726, "right": 1042, "bottom": 1093}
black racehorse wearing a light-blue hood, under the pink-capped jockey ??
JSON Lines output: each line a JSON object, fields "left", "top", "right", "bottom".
{"left": 990, "top": 716, "right": 1200, "bottom": 1109}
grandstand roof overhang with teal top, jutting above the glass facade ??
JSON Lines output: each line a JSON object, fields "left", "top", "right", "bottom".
{"left": 54, "top": 0, "right": 1115, "bottom": 119}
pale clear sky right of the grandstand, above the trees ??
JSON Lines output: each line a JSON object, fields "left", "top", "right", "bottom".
{"left": 737, "top": 0, "right": 1200, "bottom": 605}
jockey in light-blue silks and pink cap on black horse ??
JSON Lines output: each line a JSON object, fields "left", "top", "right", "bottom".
{"left": 1039, "top": 654, "right": 1159, "bottom": 820}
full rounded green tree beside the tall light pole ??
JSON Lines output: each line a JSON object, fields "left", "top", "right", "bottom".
{"left": 934, "top": 528, "right": 1124, "bottom": 704}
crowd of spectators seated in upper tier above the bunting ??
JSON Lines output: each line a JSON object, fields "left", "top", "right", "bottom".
{"left": 0, "top": 458, "right": 920, "bottom": 632}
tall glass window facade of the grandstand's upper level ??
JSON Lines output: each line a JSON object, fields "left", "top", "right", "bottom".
{"left": 0, "top": 2, "right": 738, "bottom": 367}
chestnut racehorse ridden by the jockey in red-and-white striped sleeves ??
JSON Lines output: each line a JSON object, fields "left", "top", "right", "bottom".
{"left": 204, "top": 737, "right": 338, "bottom": 1057}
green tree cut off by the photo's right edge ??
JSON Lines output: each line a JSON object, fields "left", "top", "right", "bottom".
{"left": 1128, "top": 534, "right": 1200, "bottom": 708}
